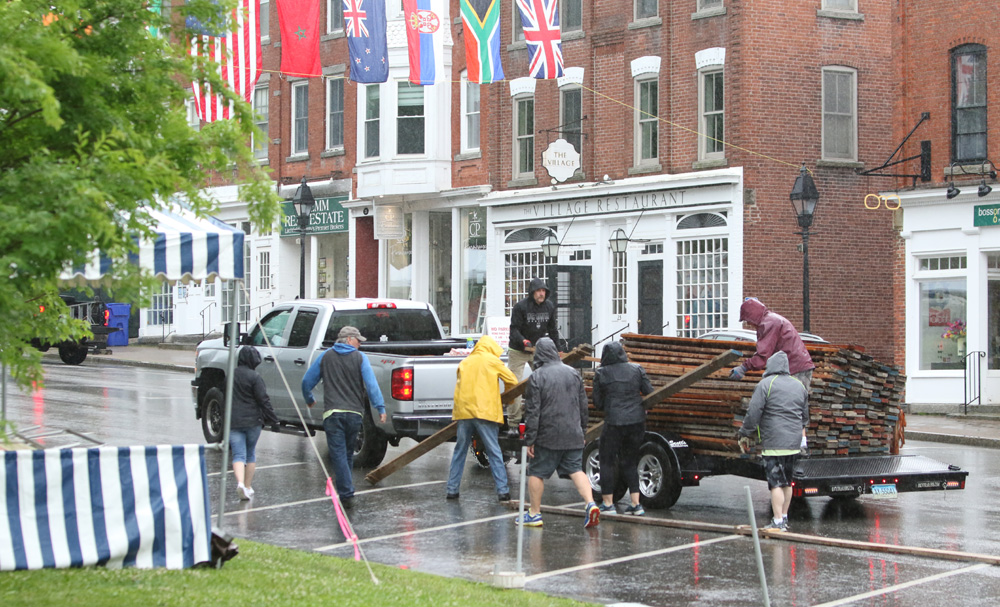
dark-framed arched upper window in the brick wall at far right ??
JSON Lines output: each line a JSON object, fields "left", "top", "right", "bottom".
{"left": 951, "top": 44, "right": 986, "bottom": 162}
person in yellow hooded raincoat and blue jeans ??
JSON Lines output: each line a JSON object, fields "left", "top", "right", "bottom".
{"left": 447, "top": 335, "right": 517, "bottom": 502}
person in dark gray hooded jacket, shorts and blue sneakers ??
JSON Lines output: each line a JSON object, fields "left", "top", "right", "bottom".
{"left": 518, "top": 337, "right": 600, "bottom": 527}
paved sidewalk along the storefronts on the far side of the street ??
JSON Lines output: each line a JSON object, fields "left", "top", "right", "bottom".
{"left": 46, "top": 344, "right": 1000, "bottom": 449}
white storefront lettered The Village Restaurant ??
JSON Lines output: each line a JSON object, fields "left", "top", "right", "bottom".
{"left": 481, "top": 168, "right": 743, "bottom": 356}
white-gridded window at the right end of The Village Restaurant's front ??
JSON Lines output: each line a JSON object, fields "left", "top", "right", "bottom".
{"left": 676, "top": 238, "right": 729, "bottom": 337}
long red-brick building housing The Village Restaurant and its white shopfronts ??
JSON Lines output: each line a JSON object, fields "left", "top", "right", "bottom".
{"left": 153, "top": 0, "right": 903, "bottom": 370}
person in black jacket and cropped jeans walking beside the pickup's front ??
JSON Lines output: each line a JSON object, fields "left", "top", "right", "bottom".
{"left": 229, "top": 346, "right": 278, "bottom": 500}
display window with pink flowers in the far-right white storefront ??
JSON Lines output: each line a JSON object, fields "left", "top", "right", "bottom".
{"left": 919, "top": 277, "right": 968, "bottom": 370}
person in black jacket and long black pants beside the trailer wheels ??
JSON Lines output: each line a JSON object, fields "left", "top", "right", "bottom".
{"left": 592, "top": 341, "right": 653, "bottom": 516}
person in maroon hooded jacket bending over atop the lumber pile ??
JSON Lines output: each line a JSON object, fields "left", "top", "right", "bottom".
{"left": 729, "top": 297, "right": 816, "bottom": 391}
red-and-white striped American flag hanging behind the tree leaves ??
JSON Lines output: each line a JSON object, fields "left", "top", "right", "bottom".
{"left": 188, "top": 0, "right": 261, "bottom": 122}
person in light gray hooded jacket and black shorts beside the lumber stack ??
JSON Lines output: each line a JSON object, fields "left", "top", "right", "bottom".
{"left": 739, "top": 351, "right": 809, "bottom": 531}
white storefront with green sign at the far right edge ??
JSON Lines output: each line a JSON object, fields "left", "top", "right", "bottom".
{"left": 900, "top": 184, "right": 1000, "bottom": 405}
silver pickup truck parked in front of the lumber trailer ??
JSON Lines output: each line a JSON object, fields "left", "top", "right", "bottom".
{"left": 191, "top": 299, "right": 467, "bottom": 467}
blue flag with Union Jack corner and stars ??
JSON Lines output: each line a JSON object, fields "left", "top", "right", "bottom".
{"left": 344, "top": 0, "right": 389, "bottom": 83}
